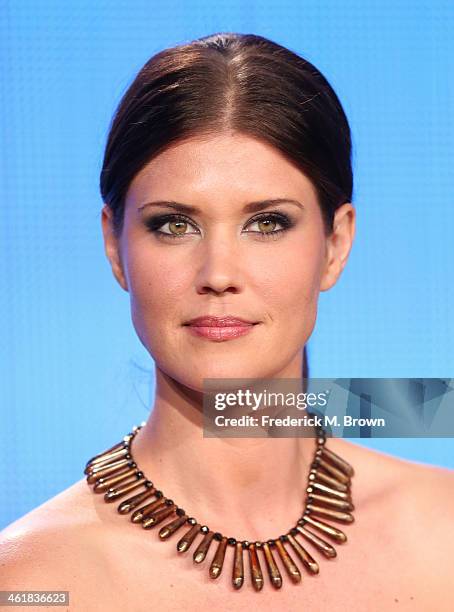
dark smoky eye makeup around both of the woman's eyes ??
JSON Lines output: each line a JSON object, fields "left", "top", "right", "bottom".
{"left": 144, "top": 212, "right": 295, "bottom": 240}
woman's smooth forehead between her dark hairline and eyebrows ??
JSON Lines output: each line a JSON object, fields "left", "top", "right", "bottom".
{"left": 126, "top": 134, "right": 316, "bottom": 212}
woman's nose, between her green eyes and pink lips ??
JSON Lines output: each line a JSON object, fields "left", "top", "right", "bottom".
{"left": 196, "top": 234, "right": 244, "bottom": 294}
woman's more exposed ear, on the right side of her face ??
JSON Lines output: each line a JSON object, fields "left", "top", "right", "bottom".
{"left": 320, "top": 202, "right": 356, "bottom": 291}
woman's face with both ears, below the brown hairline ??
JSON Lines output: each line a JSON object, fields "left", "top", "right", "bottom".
{"left": 102, "top": 133, "right": 354, "bottom": 391}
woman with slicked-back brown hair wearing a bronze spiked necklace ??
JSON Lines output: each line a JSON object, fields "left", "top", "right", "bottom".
{"left": 1, "top": 34, "right": 454, "bottom": 611}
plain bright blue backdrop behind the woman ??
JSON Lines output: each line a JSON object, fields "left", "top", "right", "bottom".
{"left": 0, "top": 0, "right": 454, "bottom": 527}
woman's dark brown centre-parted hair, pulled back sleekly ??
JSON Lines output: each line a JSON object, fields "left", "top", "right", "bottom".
{"left": 100, "top": 33, "right": 353, "bottom": 377}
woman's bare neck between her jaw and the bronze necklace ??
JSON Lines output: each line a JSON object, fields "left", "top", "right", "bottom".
{"left": 132, "top": 368, "right": 315, "bottom": 541}
